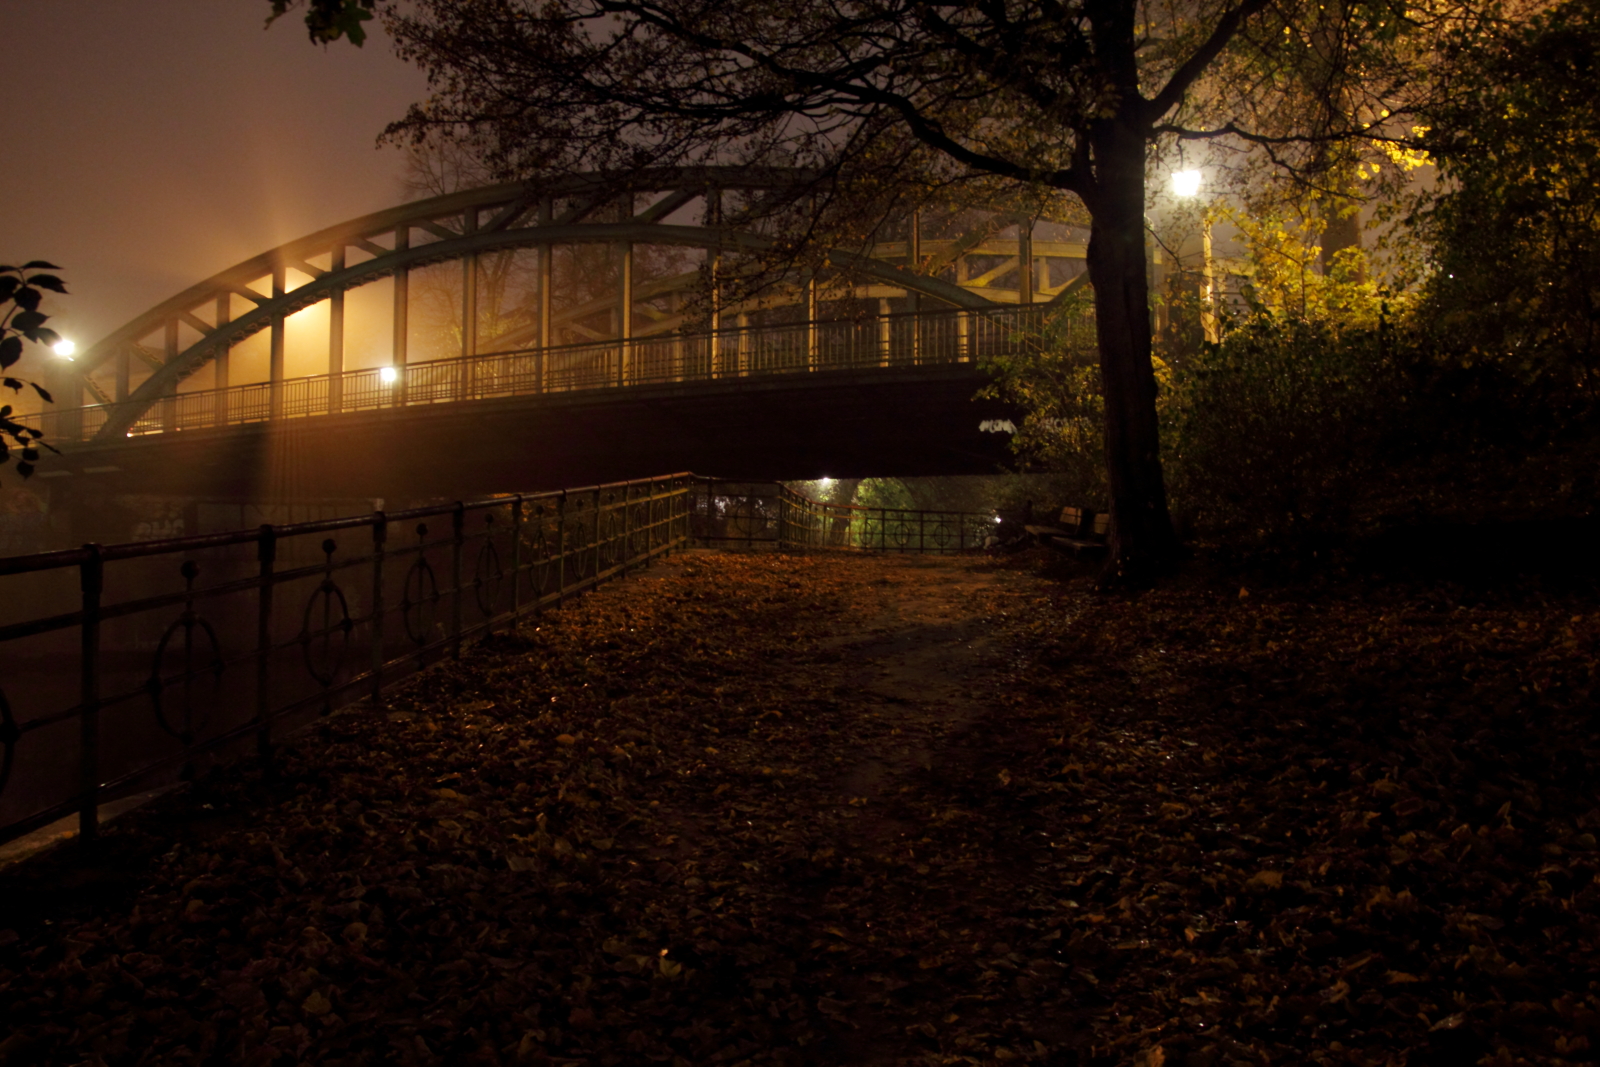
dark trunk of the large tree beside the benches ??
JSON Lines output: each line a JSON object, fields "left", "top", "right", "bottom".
{"left": 1088, "top": 120, "right": 1178, "bottom": 582}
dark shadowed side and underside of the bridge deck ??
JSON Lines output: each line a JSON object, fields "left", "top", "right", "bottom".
{"left": 51, "top": 363, "right": 1014, "bottom": 501}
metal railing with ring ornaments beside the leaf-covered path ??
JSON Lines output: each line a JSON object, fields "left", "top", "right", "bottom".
{"left": 0, "top": 474, "right": 992, "bottom": 845}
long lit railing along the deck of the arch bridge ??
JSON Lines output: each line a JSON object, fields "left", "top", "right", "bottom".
{"left": 43, "top": 306, "right": 1048, "bottom": 443}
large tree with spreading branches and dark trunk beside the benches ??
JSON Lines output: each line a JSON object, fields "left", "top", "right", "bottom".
{"left": 274, "top": 0, "right": 1450, "bottom": 579}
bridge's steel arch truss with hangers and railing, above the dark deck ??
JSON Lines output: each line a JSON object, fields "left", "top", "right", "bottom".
{"left": 56, "top": 168, "right": 1086, "bottom": 445}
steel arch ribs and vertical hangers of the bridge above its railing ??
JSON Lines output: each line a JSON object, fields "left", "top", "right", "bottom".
{"left": 59, "top": 168, "right": 1086, "bottom": 448}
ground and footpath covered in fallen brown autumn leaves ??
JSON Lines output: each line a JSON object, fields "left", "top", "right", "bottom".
{"left": 0, "top": 555, "right": 1600, "bottom": 1067}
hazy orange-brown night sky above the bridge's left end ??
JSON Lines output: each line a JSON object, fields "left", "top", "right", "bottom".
{"left": 0, "top": 0, "right": 427, "bottom": 344}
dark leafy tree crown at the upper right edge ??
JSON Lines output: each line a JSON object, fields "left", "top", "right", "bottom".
{"left": 1419, "top": 0, "right": 1600, "bottom": 399}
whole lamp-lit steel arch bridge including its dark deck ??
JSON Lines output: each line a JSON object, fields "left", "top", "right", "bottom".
{"left": 42, "top": 168, "right": 1086, "bottom": 496}
